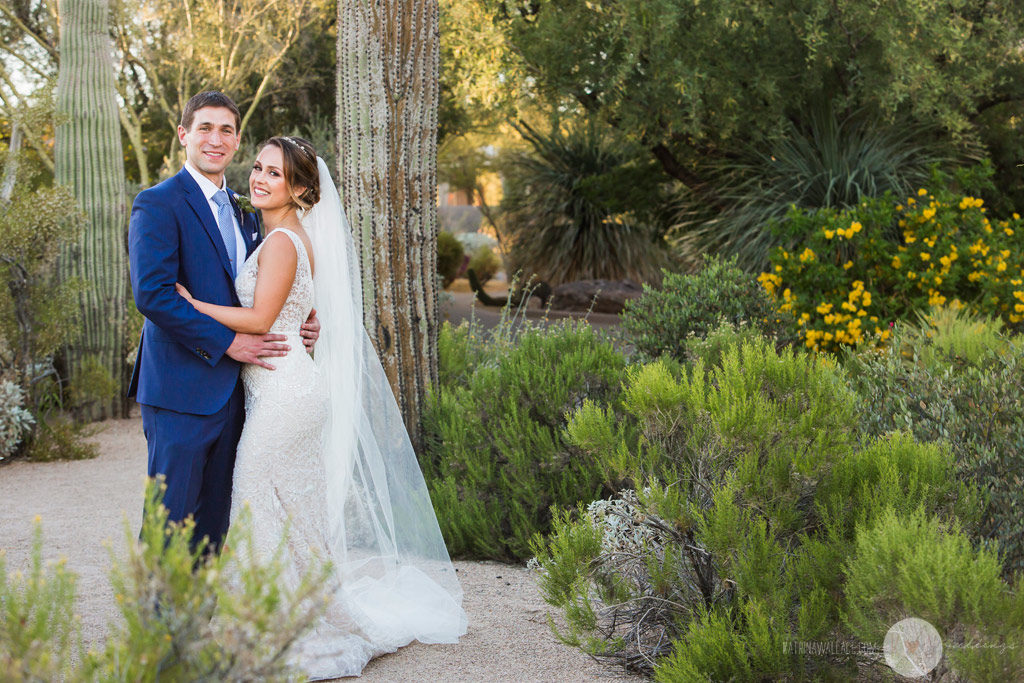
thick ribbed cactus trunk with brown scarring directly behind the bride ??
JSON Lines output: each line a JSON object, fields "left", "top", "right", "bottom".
{"left": 338, "top": 0, "right": 439, "bottom": 447}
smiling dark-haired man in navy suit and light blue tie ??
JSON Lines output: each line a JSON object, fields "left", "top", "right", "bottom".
{"left": 128, "top": 91, "right": 319, "bottom": 551}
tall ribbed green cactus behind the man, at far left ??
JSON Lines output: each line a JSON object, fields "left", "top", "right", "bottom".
{"left": 55, "top": 0, "right": 129, "bottom": 420}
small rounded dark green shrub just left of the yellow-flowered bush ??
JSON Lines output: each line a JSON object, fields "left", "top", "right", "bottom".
{"left": 622, "top": 257, "right": 792, "bottom": 358}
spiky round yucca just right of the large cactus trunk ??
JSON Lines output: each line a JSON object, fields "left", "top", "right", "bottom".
{"left": 502, "top": 125, "right": 667, "bottom": 286}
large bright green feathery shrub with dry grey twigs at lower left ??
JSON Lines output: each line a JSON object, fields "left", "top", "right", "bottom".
{"left": 532, "top": 340, "right": 978, "bottom": 681}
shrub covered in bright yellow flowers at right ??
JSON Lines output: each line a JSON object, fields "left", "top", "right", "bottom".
{"left": 758, "top": 183, "right": 1024, "bottom": 351}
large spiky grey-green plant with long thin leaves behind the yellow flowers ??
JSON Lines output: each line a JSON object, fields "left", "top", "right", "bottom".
{"left": 674, "top": 103, "right": 951, "bottom": 268}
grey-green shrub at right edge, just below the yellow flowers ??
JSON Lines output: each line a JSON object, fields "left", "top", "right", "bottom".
{"left": 847, "top": 315, "right": 1024, "bottom": 572}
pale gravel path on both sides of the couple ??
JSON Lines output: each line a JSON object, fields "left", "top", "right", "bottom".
{"left": 0, "top": 418, "right": 622, "bottom": 682}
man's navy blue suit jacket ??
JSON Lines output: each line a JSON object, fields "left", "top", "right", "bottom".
{"left": 128, "top": 169, "right": 262, "bottom": 415}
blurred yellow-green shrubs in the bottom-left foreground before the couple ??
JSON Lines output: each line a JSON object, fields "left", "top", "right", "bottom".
{"left": 0, "top": 482, "right": 330, "bottom": 681}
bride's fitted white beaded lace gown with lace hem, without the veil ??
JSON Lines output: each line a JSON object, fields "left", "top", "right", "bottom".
{"left": 231, "top": 228, "right": 385, "bottom": 680}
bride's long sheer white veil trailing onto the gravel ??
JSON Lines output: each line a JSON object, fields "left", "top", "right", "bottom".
{"left": 302, "top": 158, "right": 467, "bottom": 649}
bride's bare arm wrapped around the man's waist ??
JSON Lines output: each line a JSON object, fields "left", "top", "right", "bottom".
{"left": 175, "top": 233, "right": 298, "bottom": 335}
